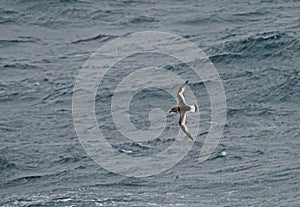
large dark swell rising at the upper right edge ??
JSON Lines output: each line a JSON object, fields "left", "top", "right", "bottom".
{"left": 210, "top": 32, "right": 300, "bottom": 64}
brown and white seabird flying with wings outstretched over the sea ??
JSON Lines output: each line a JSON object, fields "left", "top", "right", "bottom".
{"left": 169, "top": 80, "right": 197, "bottom": 140}
